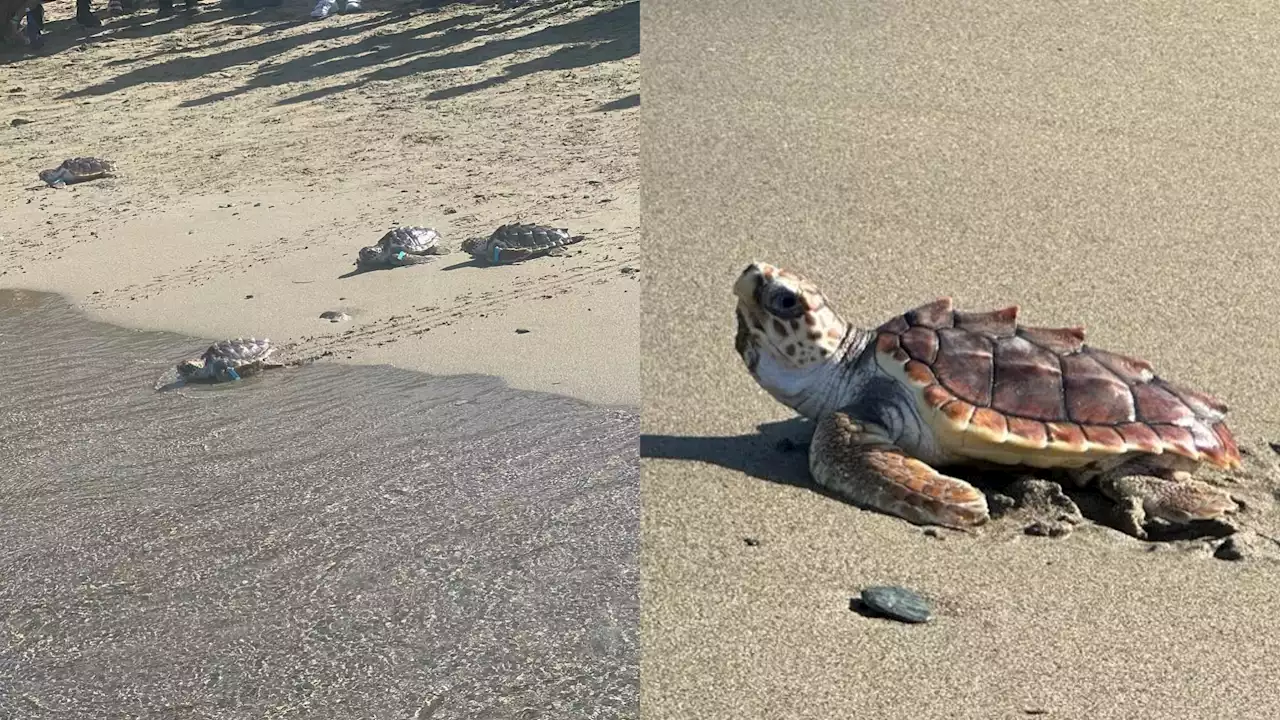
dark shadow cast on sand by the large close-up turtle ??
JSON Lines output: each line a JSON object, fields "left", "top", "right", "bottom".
{"left": 640, "top": 418, "right": 1235, "bottom": 543}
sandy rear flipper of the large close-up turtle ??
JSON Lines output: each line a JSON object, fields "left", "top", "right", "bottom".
{"left": 1098, "top": 468, "right": 1239, "bottom": 539}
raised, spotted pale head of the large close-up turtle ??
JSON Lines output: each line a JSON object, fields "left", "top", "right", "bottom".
{"left": 733, "top": 263, "right": 849, "bottom": 409}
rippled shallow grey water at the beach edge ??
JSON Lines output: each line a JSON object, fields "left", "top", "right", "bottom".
{"left": 0, "top": 291, "right": 639, "bottom": 720}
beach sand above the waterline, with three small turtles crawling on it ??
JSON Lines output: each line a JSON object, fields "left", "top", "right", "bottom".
{"left": 0, "top": 0, "right": 640, "bottom": 405}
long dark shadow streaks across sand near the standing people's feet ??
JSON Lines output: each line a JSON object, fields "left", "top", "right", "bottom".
{"left": 40, "top": 0, "right": 640, "bottom": 109}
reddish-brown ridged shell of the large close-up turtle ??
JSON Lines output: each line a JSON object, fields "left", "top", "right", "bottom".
{"left": 876, "top": 297, "right": 1240, "bottom": 469}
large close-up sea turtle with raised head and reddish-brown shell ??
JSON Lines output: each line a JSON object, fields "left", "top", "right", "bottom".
{"left": 733, "top": 263, "right": 1240, "bottom": 537}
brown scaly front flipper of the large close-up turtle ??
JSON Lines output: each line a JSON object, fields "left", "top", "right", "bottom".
{"left": 809, "top": 413, "right": 989, "bottom": 529}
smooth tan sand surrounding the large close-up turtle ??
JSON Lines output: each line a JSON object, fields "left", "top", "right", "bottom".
{"left": 641, "top": 0, "right": 1280, "bottom": 720}
